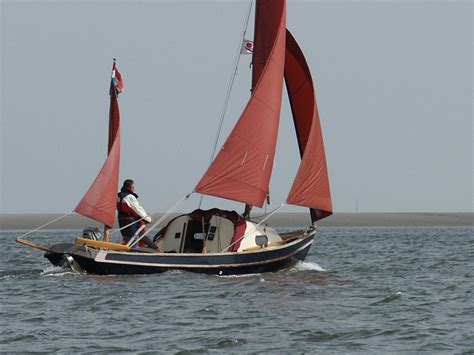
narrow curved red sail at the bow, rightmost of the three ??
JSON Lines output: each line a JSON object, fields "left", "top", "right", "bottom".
{"left": 285, "top": 30, "right": 332, "bottom": 221}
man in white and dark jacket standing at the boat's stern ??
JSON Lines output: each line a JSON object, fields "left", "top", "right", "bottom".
{"left": 117, "top": 179, "right": 157, "bottom": 249}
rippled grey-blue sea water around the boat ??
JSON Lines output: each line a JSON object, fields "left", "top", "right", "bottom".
{"left": 0, "top": 227, "right": 474, "bottom": 354}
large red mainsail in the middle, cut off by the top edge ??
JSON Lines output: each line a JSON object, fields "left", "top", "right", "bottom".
{"left": 195, "top": 0, "right": 286, "bottom": 207}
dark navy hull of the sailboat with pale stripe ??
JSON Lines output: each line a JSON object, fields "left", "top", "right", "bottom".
{"left": 45, "top": 235, "right": 314, "bottom": 275}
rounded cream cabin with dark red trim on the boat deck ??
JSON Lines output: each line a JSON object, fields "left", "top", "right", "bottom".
{"left": 153, "top": 208, "right": 283, "bottom": 254}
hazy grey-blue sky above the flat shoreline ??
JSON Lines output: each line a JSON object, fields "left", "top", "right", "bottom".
{"left": 0, "top": 0, "right": 474, "bottom": 213}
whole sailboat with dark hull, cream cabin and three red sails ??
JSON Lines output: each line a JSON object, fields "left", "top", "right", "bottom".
{"left": 16, "top": 0, "right": 332, "bottom": 275}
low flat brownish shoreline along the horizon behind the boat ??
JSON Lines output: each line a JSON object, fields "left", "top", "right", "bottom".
{"left": 0, "top": 212, "right": 474, "bottom": 230}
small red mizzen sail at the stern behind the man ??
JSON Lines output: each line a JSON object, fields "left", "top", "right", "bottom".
{"left": 74, "top": 63, "right": 121, "bottom": 227}
